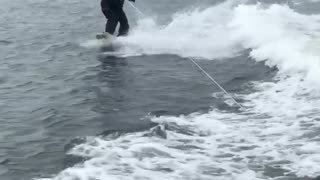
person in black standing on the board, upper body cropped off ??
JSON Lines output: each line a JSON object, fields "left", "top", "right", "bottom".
{"left": 101, "top": 0, "right": 135, "bottom": 36}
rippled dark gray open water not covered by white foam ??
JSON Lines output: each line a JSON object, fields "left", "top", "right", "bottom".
{"left": 0, "top": 0, "right": 320, "bottom": 180}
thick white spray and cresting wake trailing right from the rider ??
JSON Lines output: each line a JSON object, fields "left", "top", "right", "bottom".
{"left": 120, "top": 1, "right": 320, "bottom": 83}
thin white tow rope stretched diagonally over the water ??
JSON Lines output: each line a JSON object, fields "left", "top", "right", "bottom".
{"left": 128, "top": 1, "right": 244, "bottom": 109}
